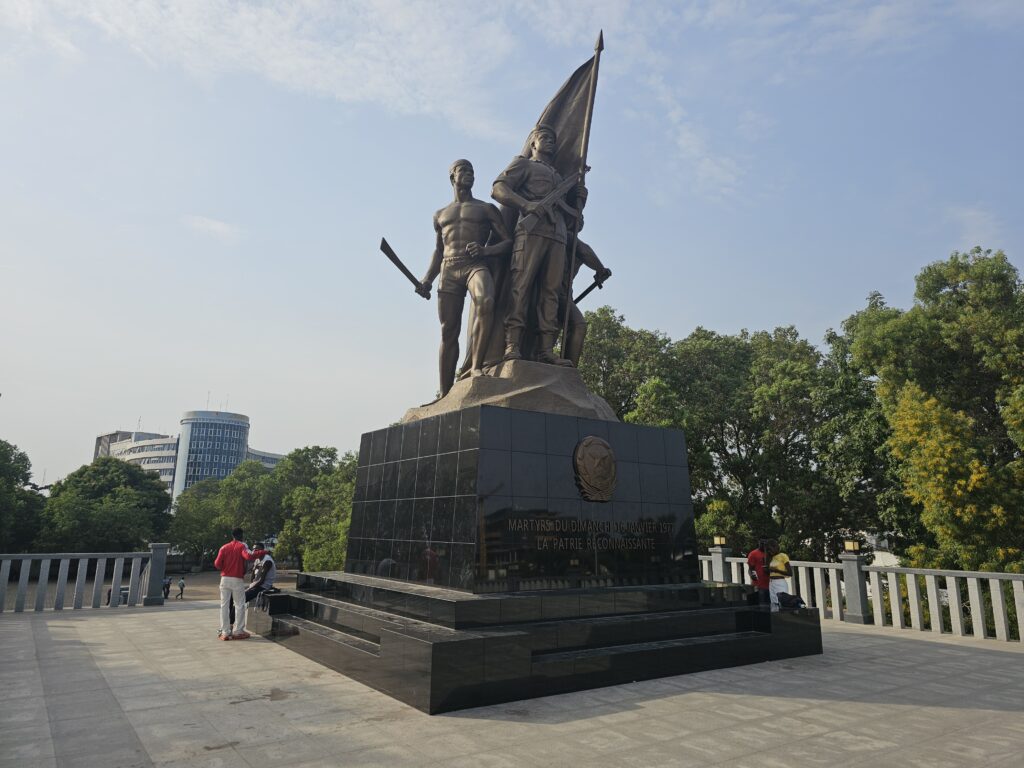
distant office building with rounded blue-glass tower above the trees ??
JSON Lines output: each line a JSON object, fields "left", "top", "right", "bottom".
{"left": 92, "top": 411, "right": 285, "bottom": 498}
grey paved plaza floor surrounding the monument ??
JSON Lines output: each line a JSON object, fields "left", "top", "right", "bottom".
{"left": 0, "top": 601, "right": 1024, "bottom": 768}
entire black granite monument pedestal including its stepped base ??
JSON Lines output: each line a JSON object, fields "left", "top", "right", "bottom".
{"left": 249, "top": 406, "right": 821, "bottom": 713}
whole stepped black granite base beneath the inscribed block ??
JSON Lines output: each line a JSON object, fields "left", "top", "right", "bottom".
{"left": 249, "top": 572, "right": 821, "bottom": 714}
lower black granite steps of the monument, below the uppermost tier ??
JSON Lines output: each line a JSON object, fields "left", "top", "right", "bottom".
{"left": 250, "top": 593, "right": 821, "bottom": 713}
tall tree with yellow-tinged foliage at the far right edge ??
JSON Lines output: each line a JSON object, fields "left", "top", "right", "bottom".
{"left": 853, "top": 248, "right": 1024, "bottom": 571}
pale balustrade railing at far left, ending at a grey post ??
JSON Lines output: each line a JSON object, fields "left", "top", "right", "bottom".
{"left": 0, "top": 544, "right": 168, "bottom": 613}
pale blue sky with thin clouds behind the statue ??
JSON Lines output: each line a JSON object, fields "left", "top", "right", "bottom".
{"left": 0, "top": 0, "right": 1024, "bottom": 481}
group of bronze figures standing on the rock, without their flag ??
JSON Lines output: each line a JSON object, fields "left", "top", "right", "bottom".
{"left": 417, "top": 124, "right": 611, "bottom": 397}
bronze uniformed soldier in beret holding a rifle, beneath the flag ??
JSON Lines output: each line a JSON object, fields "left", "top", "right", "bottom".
{"left": 490, "top": 125, "right": 572, "bottom": 366}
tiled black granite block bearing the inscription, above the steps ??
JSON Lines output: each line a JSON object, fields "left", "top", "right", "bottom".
{"left": 345, "top": 406, "right": 699, "bottom": 593}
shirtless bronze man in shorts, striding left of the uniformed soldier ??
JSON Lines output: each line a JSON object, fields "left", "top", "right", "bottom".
{"left": 416, "top": 160, "right": 512, "bottom": 397}
